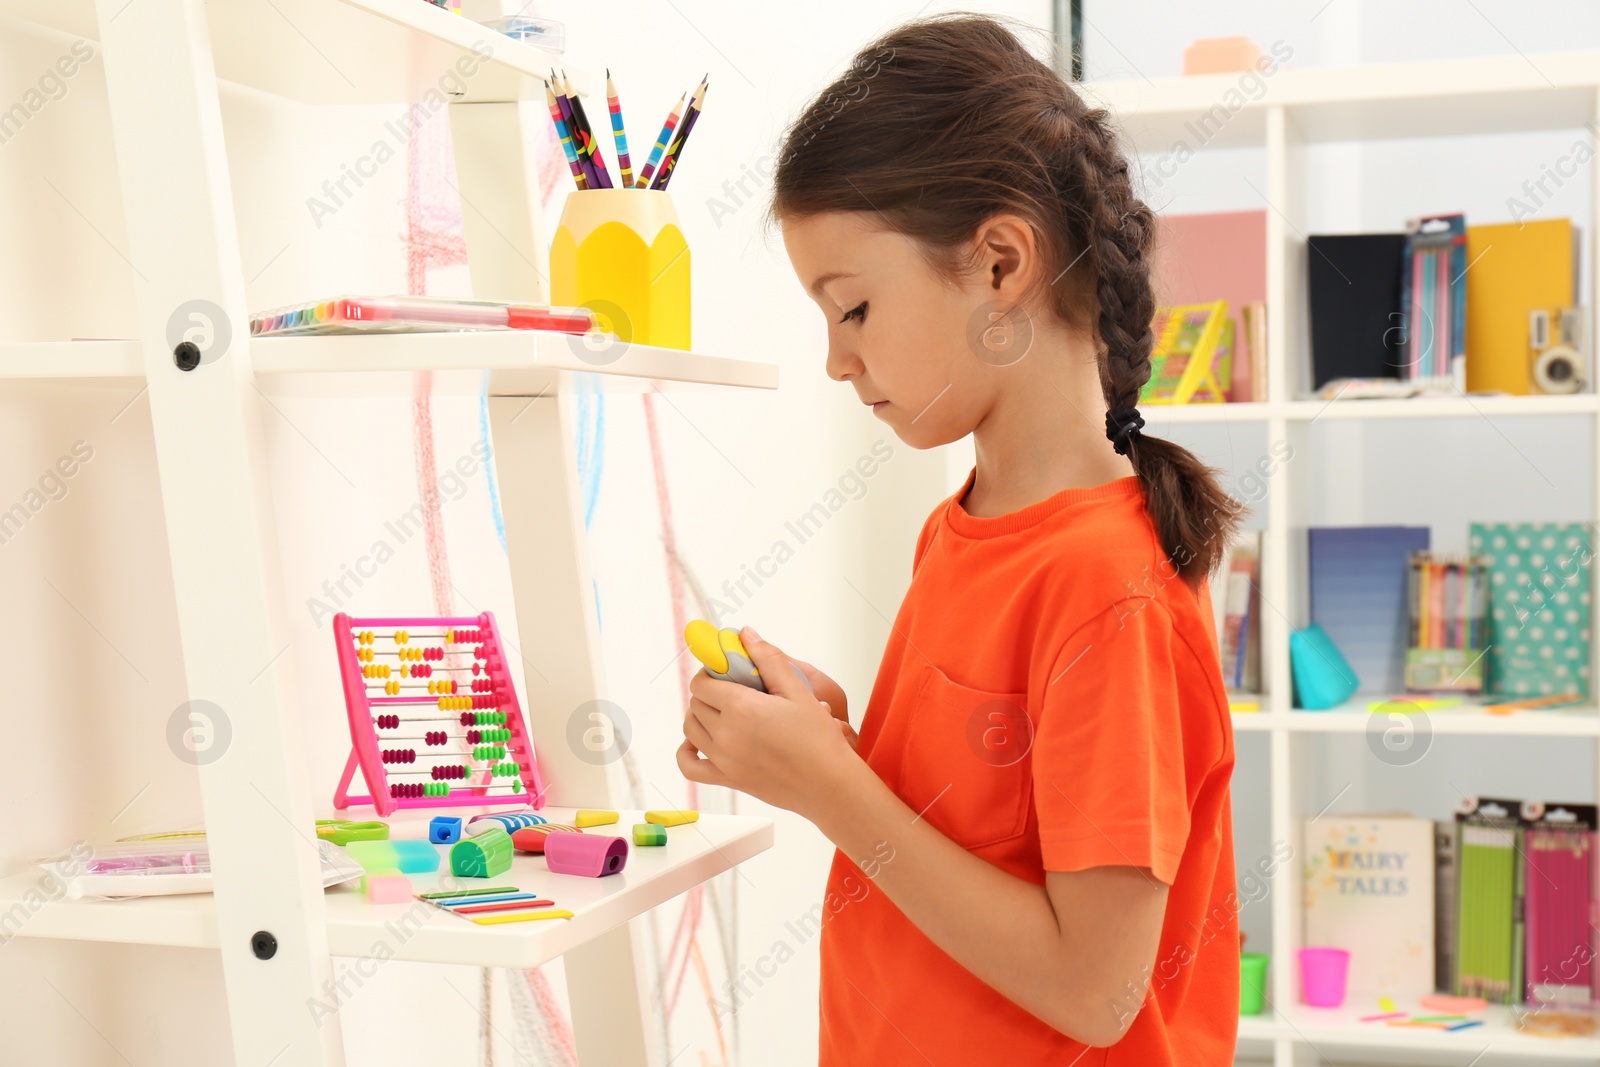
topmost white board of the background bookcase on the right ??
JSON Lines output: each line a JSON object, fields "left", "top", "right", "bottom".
{"left": 1080, "top": 42, "right": 1600, "bottom": 154}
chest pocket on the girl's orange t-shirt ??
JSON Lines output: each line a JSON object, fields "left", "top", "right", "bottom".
{"left": 896, "top": 661, "right": 1034, "bottom": 849}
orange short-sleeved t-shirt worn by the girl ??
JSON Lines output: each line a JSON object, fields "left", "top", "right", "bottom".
{"left": 819, "top": 469, "right": 1238, "bottom": 1067}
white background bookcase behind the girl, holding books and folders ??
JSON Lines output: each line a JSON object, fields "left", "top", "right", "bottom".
{"left": 1080, "top": 51, "right": 1600, "bottom": 1067}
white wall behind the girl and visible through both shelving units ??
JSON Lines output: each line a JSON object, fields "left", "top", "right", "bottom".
{"left": 0, "top": 0, "right": 1600, "bottom": 1067}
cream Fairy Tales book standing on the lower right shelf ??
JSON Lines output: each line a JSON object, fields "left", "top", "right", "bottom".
{"left": 1302, "top": 814, "right": 1435, "bottom": 1000}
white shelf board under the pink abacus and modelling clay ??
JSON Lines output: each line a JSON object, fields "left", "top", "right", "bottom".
{"left": 0, "top": 808, "right": 773, "bottom": 968}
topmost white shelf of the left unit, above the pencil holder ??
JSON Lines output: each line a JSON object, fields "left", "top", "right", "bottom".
{"left": 0, "top": 0, "right": 576, "bottom": 103}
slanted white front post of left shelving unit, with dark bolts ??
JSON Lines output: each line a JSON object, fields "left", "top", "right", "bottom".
{"left": 98, "top": 0, "right": 344, "bottom": 1067}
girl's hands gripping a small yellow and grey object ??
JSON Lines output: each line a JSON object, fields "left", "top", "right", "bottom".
{"left": 678, "top": 627, "right": 858, "bottom": 816}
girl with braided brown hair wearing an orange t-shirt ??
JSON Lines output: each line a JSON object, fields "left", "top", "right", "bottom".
{"left": 678, "top": 14, "right": 1242, "bottom": 1067}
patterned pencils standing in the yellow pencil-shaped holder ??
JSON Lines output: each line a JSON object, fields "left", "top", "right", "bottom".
{"left": 544, "top": 70, "right": 709, "bottom": 190}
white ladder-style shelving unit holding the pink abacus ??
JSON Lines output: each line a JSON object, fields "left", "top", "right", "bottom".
{"left": 0, "top": 0, "right": 778, "bottom": 1067}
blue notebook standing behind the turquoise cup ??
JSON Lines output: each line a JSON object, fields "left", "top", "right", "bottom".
{"left": 1309, "top": 526, "right": 1430, "bottom": 693}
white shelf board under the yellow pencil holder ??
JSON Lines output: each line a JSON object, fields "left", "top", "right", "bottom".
{"left": 0, "top": 330, "right": 778, "bottom": 395}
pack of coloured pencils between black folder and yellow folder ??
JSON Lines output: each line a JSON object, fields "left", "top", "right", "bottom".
{"left": 1400, "top": 214, "right": 1467, "bottom": 387}
